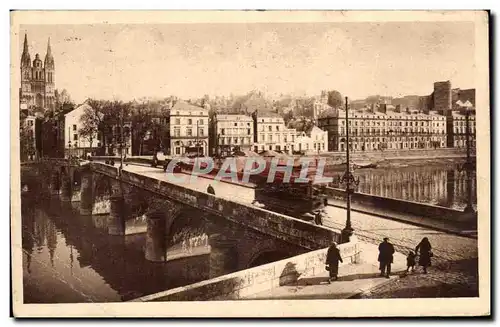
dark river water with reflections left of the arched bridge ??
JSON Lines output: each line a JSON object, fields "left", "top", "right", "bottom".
{"left": 22, "top": 200, "right": 209, "bottom": 303}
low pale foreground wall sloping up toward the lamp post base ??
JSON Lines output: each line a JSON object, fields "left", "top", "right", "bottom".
{"left": 132, "top": 237, "right": 362, "bottom": 302}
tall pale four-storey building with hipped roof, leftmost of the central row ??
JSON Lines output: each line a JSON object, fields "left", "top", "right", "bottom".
{"left": 170, "top": 101, "right": 209, "bottom": 157}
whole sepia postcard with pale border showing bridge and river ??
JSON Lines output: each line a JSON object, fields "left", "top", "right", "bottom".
{"left": 10, "top": 10, "right": 492, "bottom": 318}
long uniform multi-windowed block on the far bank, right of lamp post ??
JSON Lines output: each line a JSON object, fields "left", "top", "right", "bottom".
{"left": 318, "top": 106, "right": 446, "bottom": 151}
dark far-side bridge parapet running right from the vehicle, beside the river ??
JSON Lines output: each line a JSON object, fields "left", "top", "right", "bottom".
{"left": 326, "top": 187, "right": 477, "bottom": 226}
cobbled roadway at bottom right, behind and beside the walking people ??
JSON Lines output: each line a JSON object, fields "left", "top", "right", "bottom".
{"left": 324, "top": 207, "right": 478, "bottom": 298}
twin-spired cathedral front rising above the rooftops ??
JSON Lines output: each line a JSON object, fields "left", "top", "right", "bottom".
{"left": 19, "top": 35, "right": 55, "bottom": 110}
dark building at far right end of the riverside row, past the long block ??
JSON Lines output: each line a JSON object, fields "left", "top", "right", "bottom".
{"left": 446, "top": 110, "right": 476, "bottom": 148}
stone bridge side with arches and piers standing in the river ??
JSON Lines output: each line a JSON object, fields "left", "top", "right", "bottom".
{"left": 21, "top": 160, "right": 340, "bottom": 276}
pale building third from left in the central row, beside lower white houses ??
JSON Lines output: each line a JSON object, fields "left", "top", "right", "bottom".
{"left": 252, "top": 111, "right": 297, "bottom": 154}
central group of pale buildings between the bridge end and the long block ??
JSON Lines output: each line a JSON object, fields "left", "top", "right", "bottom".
{"left": 167, "top": 101, "right": 328, "bottom": 156}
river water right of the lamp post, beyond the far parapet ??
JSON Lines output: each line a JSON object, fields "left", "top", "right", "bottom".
{"left": 337, "top": 165, "right": 477, "bottom": 209}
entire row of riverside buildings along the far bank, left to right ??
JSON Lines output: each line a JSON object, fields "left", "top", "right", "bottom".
{"left": 21, "top": 94, "right": 476, "bottom": 161}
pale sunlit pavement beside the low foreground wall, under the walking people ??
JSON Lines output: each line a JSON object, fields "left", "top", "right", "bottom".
{"left": 245, "top": 244, "right": 406, "bottom": 300}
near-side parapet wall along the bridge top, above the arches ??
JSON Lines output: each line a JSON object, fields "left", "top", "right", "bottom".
{"left": 91, "top": 163, "right": 341, "bottom": 250}
